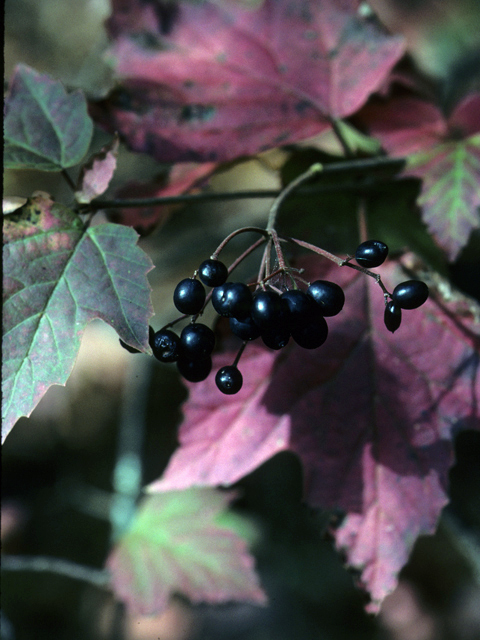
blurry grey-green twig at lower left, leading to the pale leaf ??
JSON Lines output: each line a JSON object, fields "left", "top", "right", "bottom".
{"left": 1, "top": 555, "right": 110, "bottom": 588}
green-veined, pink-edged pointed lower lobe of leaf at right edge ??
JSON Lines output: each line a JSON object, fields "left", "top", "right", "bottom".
{"left": 407, "top": 134, "right": 480, "bottom": 260}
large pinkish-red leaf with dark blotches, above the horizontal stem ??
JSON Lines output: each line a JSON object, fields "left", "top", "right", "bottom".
{"left": 92, "top": 0, "right": 403, "bottom": 162}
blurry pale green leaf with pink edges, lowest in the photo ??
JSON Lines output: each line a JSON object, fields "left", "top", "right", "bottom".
{"left": 107, "top": 488, "right": 266, "bottom": 615}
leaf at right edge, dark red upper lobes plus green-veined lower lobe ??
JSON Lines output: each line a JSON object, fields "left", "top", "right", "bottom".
{"left": 359, "top": 93, "right": 480, "bottom": 261}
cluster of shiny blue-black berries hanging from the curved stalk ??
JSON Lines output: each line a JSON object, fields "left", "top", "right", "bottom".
{"left": 150, "top": 240, "right": 428, "bottom": 394}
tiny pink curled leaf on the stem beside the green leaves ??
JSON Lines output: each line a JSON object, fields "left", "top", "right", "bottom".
{"left": 75, "top": 135, "right": 119, "bottom": 204}
